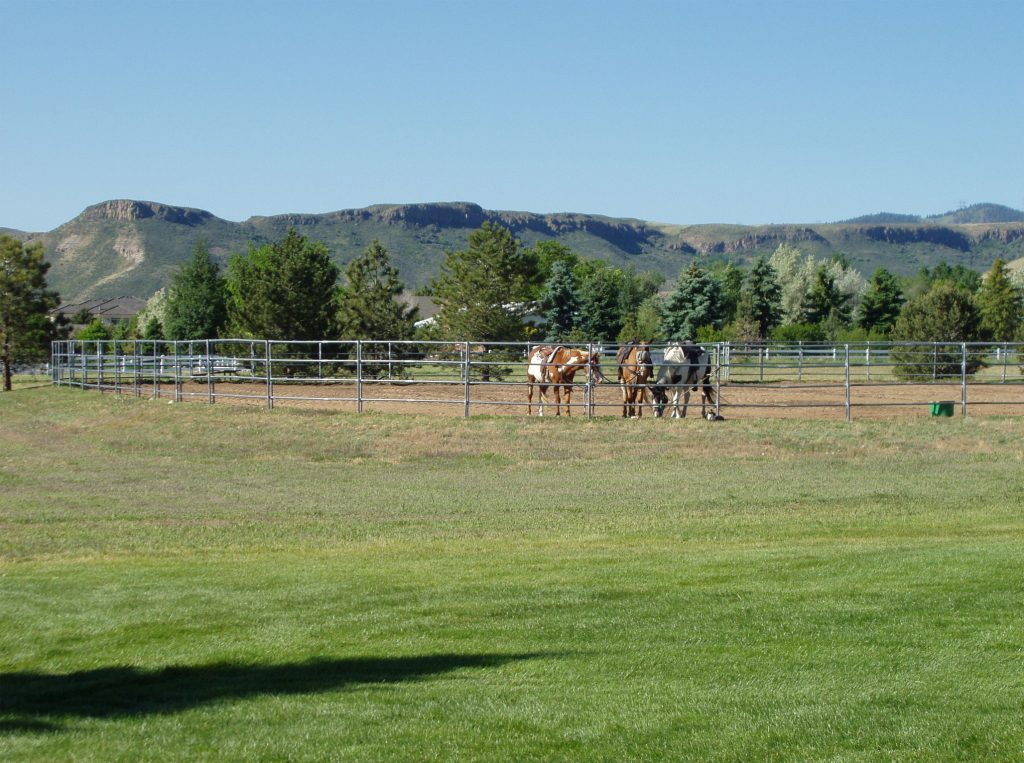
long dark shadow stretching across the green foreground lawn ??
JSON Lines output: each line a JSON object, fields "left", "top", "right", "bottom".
{"left": 0, "top": 652, "right": 557, "bottom": 733}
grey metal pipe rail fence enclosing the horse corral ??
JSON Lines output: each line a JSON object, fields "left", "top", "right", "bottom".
{"left": 50, "top": 339, "right": 1024, "bottom": 420}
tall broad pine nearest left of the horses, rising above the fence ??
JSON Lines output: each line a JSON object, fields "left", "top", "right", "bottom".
{"left": 431, "top": 222, "right": 536, "bottom": 342}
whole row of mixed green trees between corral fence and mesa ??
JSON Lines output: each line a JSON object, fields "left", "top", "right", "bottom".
{"left": 0, "top": 222, "right": 1024, "bottom": 387}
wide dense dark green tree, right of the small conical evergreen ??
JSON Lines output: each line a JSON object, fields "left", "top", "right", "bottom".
{"left": 227, "top": 228, "right": 338, "bottom": 340}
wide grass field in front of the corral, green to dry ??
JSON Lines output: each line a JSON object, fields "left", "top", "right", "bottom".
{"left": 0, "top": 387, "right": 1024, "bottom": 761}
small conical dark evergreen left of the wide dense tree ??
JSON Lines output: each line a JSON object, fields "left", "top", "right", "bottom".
{"left": 164, "top": 241, "right": 227, "bottom": 339}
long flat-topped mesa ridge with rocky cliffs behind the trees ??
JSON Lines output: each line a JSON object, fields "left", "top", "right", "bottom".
{"left": 5, "top": 200, "right": 1024, "bottom": 302}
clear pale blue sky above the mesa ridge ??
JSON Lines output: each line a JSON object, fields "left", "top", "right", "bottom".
{"left": 0, "top": 0, "right": 1024, "bottom": 230}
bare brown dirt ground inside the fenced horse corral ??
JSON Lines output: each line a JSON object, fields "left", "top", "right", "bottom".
{"left": 105, "top": 380, "right": 1024, "bottom": 421}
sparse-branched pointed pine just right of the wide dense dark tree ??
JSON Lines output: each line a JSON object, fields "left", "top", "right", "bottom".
{"left": 338, "top": 239, "right": 417, "bottom": 340}
